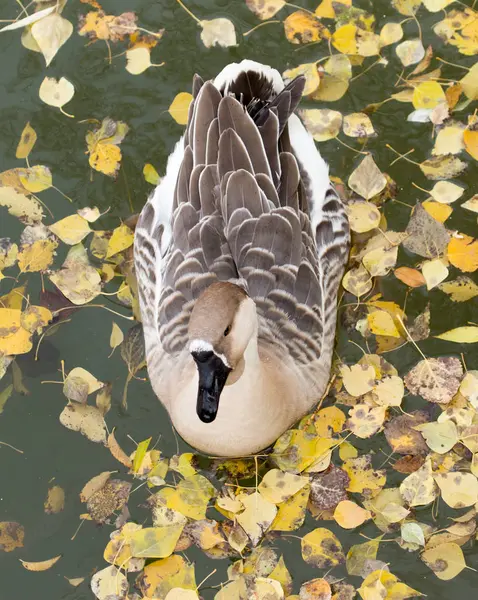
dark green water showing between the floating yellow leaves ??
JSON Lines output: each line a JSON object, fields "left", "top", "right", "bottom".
{"left": 0, "top": 0, "right": 478, "bottom": 600}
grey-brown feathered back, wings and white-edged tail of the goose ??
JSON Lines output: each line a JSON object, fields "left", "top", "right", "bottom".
{"left": 135, "top": 61, "right": 349, "bottom": 446}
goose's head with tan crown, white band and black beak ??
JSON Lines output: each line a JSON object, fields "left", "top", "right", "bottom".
{"left": 189, "top": 282, "right": 257, "bottom": 423}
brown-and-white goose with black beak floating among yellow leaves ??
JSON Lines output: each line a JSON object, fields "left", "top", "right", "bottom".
{"left": 134, "top": 60, "right": 350, "bottom": 457}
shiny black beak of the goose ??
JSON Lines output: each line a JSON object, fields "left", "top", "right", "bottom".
{"left": 192, "top": 351, "right": 231, "bottom": 423}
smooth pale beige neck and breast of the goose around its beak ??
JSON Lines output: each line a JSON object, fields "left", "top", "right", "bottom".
{"left": 170, "top": 333, "right": 303, "bottom": 456}
